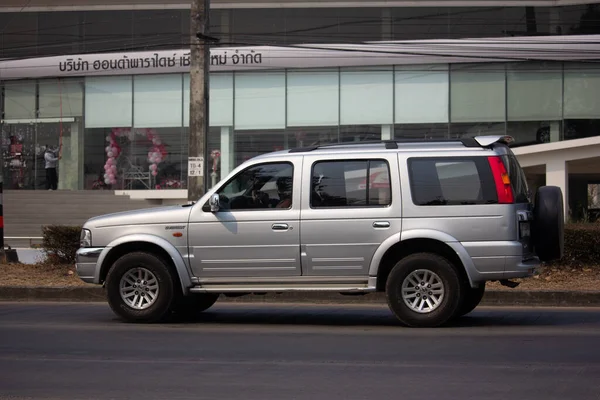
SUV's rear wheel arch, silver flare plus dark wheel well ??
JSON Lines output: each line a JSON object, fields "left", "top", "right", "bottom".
{"left": 369, "top": 230, "right": 477, "bottom": 291}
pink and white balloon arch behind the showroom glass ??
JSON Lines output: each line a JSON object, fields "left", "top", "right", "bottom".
{"left": 104, "top": 128, "right": 167, "bottom": 185}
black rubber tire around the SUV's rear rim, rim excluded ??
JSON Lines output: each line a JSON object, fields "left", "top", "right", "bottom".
{"left": 386, "top": 253, "right": 464, "bottom": 327}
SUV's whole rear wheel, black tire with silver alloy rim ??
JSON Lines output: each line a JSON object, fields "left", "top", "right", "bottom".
{"left": 386, "top": 253, "right": 463, "bottom": 327}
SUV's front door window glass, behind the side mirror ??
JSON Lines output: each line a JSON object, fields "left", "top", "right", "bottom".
{"left": 217, "top": 163, "right": 294, "bottom": 210}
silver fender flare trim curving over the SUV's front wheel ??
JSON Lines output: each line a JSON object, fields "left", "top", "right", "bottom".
{"left": 94, "top": 234, "right": 193, "bottom": 294}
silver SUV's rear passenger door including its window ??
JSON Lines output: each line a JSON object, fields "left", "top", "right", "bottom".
{"left": 300, "top": 152, "right": 401, "bottom": 277}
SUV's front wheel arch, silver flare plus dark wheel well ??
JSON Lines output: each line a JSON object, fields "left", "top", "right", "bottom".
{"left": 96, "top": 234, "right": 193, "bottom": 294}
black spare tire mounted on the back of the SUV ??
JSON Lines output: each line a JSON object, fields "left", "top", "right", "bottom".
{"left": 531, "top": 186, "right": 565, "bottom": 262}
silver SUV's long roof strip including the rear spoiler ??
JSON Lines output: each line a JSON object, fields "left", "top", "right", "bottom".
{"left": 253, "top": 135, "right": 514, "bottom": 160}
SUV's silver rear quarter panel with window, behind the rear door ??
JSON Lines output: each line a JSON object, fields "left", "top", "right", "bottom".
{"left": 400, "top": 149, "right": 522, "bottom": 273}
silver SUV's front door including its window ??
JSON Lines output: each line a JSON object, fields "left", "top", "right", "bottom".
{"left": 189, "top": 157, "right": 302, "bottom": 278}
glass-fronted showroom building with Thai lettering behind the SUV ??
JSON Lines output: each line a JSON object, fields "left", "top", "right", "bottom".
{"left": 0, "top": 1, "right": 600, "bottom": 217}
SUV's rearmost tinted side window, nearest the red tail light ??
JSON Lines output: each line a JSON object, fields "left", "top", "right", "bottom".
{"left": 408, "top": 157, "right": 498, "bottom": 206}
